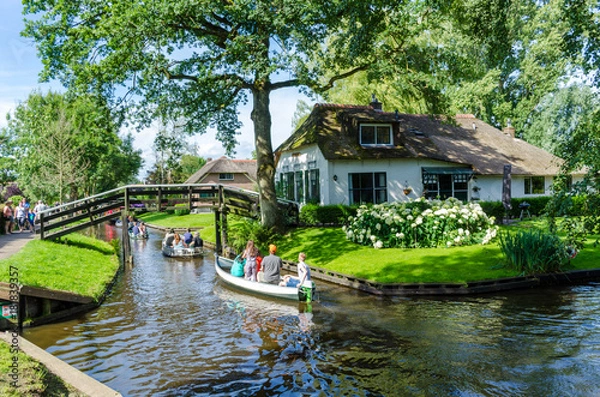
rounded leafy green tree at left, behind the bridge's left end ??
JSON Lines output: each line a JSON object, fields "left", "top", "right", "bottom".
{"left": 3, "top": 92, "right": 142, "bottom": 201}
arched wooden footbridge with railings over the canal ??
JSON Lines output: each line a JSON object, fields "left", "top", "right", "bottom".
{"left": 36, "top": 184, "right": 299, "bottom": 253}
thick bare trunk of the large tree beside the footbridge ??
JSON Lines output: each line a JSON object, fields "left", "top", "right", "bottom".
{"left": 251, "top": 87, "right": 283, "bottom": 230}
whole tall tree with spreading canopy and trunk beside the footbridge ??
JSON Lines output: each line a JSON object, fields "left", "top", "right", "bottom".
{"left": 24, "top": 0, "right": 460, "bottom": 226}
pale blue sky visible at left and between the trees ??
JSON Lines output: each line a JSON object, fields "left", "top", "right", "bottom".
{"left": 0, "top": 0, "right": 310, "bottom": 176}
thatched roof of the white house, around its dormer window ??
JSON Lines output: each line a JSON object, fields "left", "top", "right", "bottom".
{"left": 276, "top": 104, "right": 562, "bottom": 175}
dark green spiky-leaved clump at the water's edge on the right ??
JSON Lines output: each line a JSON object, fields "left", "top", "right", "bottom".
{"left": 499, "top": 230, "right": 569, "bottom": 275}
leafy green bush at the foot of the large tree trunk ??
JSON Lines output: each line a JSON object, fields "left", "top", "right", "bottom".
{"left": 228, "top": 217, "right": 277, "bottom": 255}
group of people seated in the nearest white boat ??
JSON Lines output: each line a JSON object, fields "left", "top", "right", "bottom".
{"left": 241, "top": 240, "right": 311, "bottom": 288}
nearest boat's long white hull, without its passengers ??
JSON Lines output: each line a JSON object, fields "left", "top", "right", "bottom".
{"left": 215, "top": 254, "right": 315, "bottom": 302}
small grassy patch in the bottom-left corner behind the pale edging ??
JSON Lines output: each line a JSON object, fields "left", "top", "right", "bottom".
{"left": 0, "top": 341, "right": 84, "bottom": 397}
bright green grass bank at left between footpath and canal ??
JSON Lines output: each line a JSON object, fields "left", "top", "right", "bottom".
{"left": 0, "top": 234, "right": 119, "bottom": 299}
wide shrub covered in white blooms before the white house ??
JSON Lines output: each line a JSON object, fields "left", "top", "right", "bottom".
{"left": 343, "top": 198, "right": 498, "bottom": 248}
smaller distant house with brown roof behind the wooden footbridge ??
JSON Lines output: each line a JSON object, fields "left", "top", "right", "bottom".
{"left": 185, "top": 156, "right": 257, "bottom": 191}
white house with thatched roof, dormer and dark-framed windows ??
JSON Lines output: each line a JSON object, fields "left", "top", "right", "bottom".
{"left": 275, "top": 100, "right": 584, "bottom": 204}
